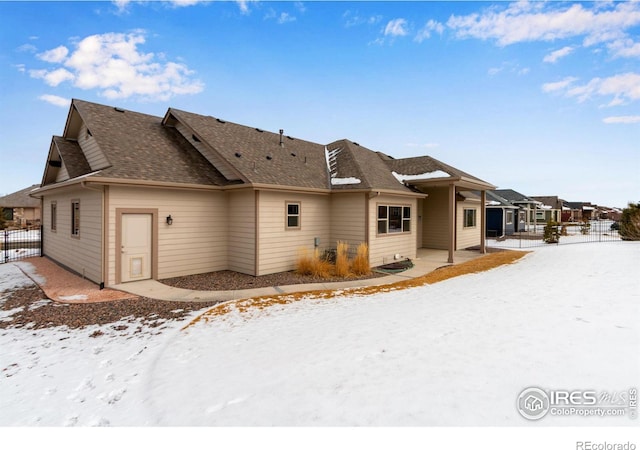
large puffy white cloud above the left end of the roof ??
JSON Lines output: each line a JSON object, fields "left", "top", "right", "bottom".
{"left": 30, "top": 31, "right": 203, "bottom": 101}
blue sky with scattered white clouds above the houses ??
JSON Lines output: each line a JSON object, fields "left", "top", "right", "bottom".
{"left": 0, "top": 0, "right": 640, "bottom": 207}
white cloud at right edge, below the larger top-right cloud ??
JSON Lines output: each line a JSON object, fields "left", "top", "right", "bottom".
{"left": 542, "top": 72, "right": 640, "bottom": 106}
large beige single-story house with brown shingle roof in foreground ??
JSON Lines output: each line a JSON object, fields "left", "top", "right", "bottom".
{"left": 31, "top": 100, "right": 494, "bottom": 285}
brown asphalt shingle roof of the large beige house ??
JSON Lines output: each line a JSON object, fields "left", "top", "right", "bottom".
{"left": 41, "top": 100, "right": 496, "bottom": 193}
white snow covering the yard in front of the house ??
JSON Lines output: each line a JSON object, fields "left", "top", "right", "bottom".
{"left": 0, "top": 242, "right": 640, "bottom": 427}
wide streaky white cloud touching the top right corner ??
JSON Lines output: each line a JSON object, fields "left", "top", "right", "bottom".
{"left": 447, "top": 1, "right": 640, "bottom": 51}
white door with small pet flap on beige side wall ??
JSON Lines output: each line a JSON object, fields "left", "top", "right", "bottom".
{"left": 120, "top": 214, "right": 153, "bottom": 283}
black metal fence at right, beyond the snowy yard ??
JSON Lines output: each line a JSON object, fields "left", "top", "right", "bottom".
{"left": 486, "top": 220, "right": 621, "bottom": 248}
